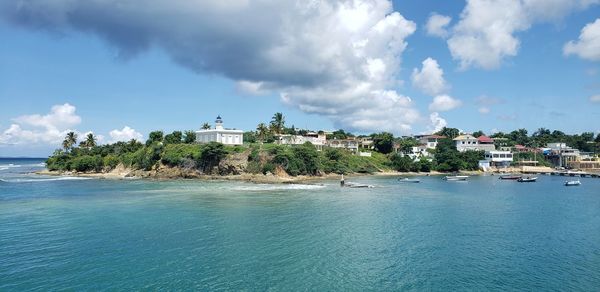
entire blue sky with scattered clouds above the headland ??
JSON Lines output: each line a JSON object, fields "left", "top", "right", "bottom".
{"left": 0, "top": 0, "right": 600, "bottom": 157}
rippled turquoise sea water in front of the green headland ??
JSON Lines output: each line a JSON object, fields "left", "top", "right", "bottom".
{"left": 0, "top": 160, "right": 600, "bottom": 291}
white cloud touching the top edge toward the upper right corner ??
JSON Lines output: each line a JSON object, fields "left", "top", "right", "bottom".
{"left": 447, "top": 0, "right": 599, "bottom": 69}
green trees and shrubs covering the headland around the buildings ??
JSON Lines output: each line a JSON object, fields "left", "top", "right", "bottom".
{"left": 46, "top": 113, "right": 600, "bottom": 176}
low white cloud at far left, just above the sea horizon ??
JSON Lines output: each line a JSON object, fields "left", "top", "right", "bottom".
{"left": 0, "top": 103, "right": 81, "bottom": 145}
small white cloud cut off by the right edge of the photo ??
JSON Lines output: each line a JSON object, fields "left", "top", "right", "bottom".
{"left": 563, "top": 18, "right": 600, "bottom": 61}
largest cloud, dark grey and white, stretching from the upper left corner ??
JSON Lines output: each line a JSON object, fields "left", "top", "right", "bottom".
{"left": 0, "top": 0, "right": 420, "bottom": 132}
